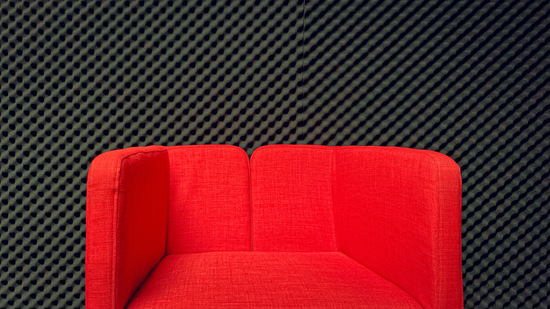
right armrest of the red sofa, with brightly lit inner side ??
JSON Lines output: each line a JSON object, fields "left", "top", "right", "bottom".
{"left": 334, "top": 147, "right": 463, "bottom": 308}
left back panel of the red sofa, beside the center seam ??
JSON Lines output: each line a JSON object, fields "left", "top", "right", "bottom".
{"left": 166, "top": 145, "right": 250, "bottom": 254}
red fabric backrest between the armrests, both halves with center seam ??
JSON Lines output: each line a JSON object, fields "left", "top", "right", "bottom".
{"left": 166, "top": 145, "right": 337, "bottom": 254}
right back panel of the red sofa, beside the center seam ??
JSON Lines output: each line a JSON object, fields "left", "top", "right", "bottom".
{"left": 250, "top": 145, "right": 336, "bottom": 252}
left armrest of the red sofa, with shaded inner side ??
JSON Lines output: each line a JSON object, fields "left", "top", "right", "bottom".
{"left": 86, "top": 146, "right": 169, "bottom": 308}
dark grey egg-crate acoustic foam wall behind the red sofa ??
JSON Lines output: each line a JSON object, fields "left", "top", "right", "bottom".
{"left": 0, "top": 0, "right": 550, "bottom": 308}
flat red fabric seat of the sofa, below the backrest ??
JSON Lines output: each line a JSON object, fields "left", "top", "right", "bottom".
{"left": 128, "top": 251, "right": 421, "bottom": 308}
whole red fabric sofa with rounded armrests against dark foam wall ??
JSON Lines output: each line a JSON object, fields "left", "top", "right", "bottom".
{"left": 86, "top": 145, "right": 463, "bottom": 308}
